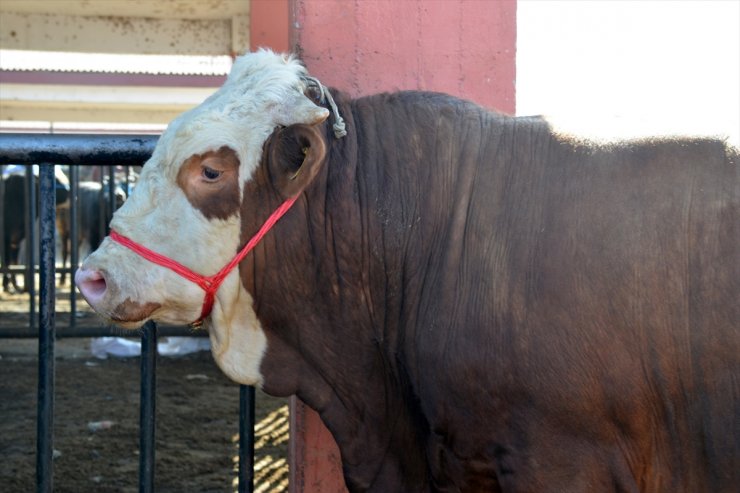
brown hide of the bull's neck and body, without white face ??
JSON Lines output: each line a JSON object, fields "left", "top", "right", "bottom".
{"left": 241, "top": 93, "right": 740, "bottom": 492}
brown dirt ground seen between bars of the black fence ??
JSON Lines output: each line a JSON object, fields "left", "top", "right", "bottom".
{"left": 0, "top": 280, "right": 288, "bottom": 493}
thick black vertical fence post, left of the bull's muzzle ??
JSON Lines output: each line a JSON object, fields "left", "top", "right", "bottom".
{"left": 32, "top": 164, "right": 56, "bottom": 493}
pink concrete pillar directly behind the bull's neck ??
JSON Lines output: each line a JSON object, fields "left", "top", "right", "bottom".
{"left": 286, "top": 0, "right": 516, "bottom": 493}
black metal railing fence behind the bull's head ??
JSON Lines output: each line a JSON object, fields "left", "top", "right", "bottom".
{"left": 0, "top": 134, "right": 255, "bottom": 492}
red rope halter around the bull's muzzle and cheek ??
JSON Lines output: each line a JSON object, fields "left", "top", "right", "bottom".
{"left": 110, "top": 196, "right": 298, "bottom": 328}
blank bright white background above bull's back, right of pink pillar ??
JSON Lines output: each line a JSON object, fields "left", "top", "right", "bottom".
{"left": 516, "top": 0, "right": 740, "bottom": 145}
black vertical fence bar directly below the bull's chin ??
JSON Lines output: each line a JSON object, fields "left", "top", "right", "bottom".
{"left": 139, "top": 322, "right": 157, "bottom": 493}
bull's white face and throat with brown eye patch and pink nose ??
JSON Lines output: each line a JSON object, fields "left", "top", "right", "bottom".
{"left": 76, "top": 51, "right": 329, "bottom": 384}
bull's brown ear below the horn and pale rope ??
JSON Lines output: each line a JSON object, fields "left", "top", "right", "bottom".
{"left": 266, "top": 125, "right": 326, "bottom": 199}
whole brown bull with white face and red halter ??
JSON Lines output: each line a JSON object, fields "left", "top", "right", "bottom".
{"left": 76, "top": 51, "right": 740, "bottom": 492}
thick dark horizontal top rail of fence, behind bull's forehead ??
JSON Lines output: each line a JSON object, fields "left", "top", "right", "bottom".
{"left": 0, "top": 133, "right": 159, "bottom": 166}
